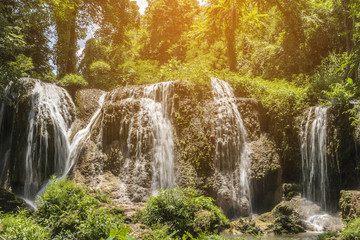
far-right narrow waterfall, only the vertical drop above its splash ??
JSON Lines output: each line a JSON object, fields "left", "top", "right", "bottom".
{"left": 300, "top": 107, "right": 329, "bottom": 211}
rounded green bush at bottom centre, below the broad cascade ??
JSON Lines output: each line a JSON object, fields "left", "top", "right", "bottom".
{"left": 144, "top": 188, "right": 229, "bottom": 237}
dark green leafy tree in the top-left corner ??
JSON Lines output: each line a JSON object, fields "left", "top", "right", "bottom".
{"left": 0, "top": 0, "right": 51, "bottom": 97}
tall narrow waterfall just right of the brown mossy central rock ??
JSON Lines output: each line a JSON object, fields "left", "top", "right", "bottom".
{"left": 211, "top": 78, "right": 251, "bottom": 214}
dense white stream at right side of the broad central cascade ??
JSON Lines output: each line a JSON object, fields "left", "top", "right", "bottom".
{"left": 121, "top": 82, "right": 175, "bottom": 194}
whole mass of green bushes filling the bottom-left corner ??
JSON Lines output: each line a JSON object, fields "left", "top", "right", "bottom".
{"left": 0, "top": 179, "right": 132, "bottom": 240}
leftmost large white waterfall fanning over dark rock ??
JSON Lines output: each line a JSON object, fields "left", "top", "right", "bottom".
{"left": 23, "top": 80, "right": 75, "bottom": 199}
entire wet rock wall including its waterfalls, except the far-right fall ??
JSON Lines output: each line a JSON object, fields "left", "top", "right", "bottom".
{"left": 0, "top": 80, "right": 281, "bottom": 216}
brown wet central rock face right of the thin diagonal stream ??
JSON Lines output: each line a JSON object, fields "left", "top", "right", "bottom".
{"left": 74, "top": 82, "right": 281, "bottom": 214}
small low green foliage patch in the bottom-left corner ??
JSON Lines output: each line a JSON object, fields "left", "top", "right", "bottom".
{"left": 0, "top": 209, "right": 51, "bottom": 240}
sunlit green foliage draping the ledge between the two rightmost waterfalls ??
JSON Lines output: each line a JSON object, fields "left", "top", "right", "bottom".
{"left": 218, "top": 72, "right": 309, "bottom": 152}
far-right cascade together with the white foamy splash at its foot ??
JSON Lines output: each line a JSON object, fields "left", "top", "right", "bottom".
{"left": 300, "top": 107, "right": 342, "bottom": 232}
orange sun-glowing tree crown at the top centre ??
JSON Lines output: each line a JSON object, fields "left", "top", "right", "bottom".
{"left": 142, "top": 0, "right": 200, "bottom": 63}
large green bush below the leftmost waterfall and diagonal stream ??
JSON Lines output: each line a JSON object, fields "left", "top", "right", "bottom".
{"left": 35, "top": 179, "right": 131, "bottom": 240}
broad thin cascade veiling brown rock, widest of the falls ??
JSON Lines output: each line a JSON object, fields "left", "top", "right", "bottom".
{"left": 91, "top": 82, "right": 175, "bottom": 202}
